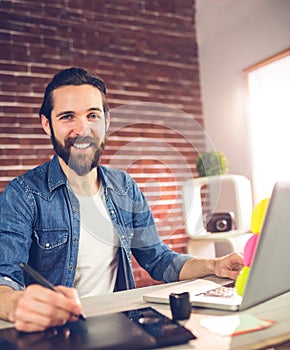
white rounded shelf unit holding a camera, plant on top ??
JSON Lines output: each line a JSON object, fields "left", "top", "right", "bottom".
{"left": 182, "top": 174, "right": 253, "bottom": 257}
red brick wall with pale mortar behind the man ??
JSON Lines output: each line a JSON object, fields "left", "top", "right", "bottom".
{"left": 0, "top": 0, "right": 204, "bottom": 286}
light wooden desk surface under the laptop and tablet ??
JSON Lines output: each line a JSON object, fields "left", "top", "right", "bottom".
{"left": 0, "top": 282, "right": 290, "bottom": 350}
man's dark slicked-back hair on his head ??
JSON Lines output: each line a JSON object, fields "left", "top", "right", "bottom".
{"left": 39, "top": 67, "right": 109, "bottom": 122}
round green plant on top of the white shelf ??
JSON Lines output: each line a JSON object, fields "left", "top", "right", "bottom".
{"left": 196, "top": 151, "right": 229, "bottom": 177}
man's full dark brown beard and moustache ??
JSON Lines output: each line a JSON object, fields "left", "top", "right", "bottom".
{"left": 51, "top": 129, "right": 107, "bottom": 176}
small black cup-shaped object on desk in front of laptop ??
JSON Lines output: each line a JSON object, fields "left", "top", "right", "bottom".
{"left": 169, "top": 292, "right": 191, "bottom": 320}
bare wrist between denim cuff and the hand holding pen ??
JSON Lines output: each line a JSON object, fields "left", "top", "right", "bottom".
{"left": 0, "top": 285, "right": 22, "bottom": 322}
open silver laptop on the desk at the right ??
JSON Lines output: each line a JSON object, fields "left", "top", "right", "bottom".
{"left": 143, "top": 181, "right": 290, "bottom": 311}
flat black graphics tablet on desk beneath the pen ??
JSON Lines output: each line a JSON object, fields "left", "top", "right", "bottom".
{"left": 0, "top": 307, "right": 195, "bottom": 350}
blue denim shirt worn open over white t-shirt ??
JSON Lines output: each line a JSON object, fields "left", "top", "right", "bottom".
{"left": 0, "top": 156, "right": 190, "bottom": 291}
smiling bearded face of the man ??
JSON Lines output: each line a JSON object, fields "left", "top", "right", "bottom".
{"left": 50, "top": 85, "right": 108, "bottom": 176}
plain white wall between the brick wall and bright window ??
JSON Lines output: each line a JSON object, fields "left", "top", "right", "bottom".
{"left": 196, "top": 0, "right": 290, "bottom": 202}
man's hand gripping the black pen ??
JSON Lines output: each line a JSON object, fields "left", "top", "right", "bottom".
{"left": 9, "top": 284, "right": 82, "bottom": 332}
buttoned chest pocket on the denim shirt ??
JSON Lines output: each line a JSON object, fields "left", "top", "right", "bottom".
{"left": 30, "top": 228, "right": 69, "bottom": 275}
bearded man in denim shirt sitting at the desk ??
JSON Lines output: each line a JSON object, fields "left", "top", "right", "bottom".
{"left": 0, "top": 68, "right": 242, "bottom": 332}
